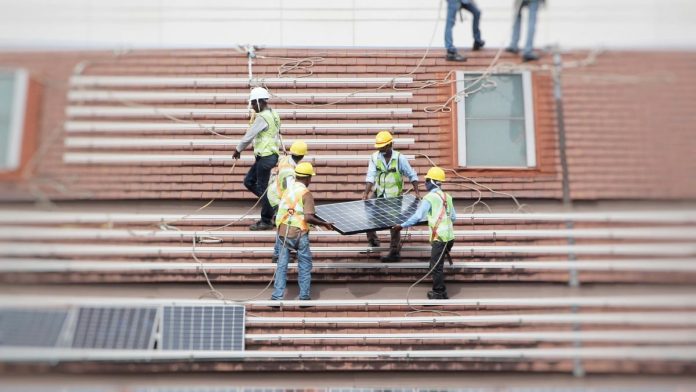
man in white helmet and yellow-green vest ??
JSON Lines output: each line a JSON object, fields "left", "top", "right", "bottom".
{"left": 232, "top": 87, "right": 280, "bottom": 230}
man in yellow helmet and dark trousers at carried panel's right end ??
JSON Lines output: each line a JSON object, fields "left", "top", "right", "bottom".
{"left": 392, "top": 167, "right": 457, "bottom": 299}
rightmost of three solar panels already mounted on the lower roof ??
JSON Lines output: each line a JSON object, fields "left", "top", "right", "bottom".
{"left": 160, "top": 305, "right": 244, "bottom": 351}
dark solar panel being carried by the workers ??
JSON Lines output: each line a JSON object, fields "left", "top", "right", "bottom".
{"left": 316, "top": 195, "right": 422, "bottom": 234}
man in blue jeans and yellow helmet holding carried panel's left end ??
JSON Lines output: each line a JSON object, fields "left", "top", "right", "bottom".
{"left": 271, "top": 162, "right": 333, "bottom": 300}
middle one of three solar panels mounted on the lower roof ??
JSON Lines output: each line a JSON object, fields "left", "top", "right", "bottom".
{"left": 72, "top": 307, "right": 157, "bottom": 349}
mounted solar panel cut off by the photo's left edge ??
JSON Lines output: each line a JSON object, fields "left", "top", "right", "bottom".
{"left": 0, "top": 309, "right": 68, "bottom": 347}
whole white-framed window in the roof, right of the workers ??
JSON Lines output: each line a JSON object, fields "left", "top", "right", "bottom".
{"left": 457, "top": 71, "right": 536, "bottom": 169}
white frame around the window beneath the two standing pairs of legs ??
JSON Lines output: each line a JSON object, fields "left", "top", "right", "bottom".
{"left": 457, "top": 71, "right": 537, "bottom": 169}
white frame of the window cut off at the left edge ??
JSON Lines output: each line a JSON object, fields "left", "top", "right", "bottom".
{"left": 0, "top": 69, "right": 29, "bottom": 171}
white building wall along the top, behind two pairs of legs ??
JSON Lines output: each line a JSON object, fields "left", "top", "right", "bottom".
{"left": 0, "top": 0, "right": 696, "bottom": 49}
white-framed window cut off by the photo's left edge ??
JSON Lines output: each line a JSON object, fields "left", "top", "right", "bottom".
{"left": 0, "top": 70, "right": 29, "bottom": 171}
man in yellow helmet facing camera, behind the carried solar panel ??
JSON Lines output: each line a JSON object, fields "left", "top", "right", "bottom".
{"left": 362, "top": 131, "right": 420, "bottom": 263}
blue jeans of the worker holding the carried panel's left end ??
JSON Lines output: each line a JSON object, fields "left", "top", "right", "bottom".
{"left": 271, "top": 233, "right": 312, "bottom": 300}
